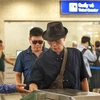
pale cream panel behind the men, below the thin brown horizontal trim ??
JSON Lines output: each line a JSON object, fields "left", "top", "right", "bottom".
{"left": 4, "top": 21, "right": 100, "bottom": 56}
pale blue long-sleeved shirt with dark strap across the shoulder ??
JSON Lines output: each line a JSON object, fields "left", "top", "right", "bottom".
{"left": 77, "top": 45, "right": 97, "bottom": 77}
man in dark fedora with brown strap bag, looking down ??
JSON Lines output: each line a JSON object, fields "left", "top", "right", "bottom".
{"left": 29, "top": 21, "right": 89, "bottom": 91}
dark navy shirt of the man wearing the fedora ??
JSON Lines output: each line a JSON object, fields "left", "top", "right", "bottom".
{"left": 29, "top": 48, "right": 88, "bottom": 89}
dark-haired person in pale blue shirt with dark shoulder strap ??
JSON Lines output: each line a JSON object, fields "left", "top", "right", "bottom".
{"left": 77, "top": 36, "right": 97, "bottom": 78}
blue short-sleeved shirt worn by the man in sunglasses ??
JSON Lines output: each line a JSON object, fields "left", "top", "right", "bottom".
{"left": 14, "top": 47, "right": 46, "bottom": 89}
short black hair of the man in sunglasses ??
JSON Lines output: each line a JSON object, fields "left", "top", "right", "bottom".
{"left": 29, "top": 27, "right": 43, "bottom": 37}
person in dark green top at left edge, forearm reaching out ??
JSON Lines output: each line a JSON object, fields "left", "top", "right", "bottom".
{"left": 0, "top": 40, "right": 14, "bottom": 100}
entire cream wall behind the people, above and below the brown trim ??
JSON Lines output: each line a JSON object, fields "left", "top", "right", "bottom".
{"left": 0, "top": 0, "right": 100, "bottom": 56}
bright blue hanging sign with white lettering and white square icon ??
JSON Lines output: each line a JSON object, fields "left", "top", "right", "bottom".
{"left": 60, "top": 1, "right": 100, "bottom": 14}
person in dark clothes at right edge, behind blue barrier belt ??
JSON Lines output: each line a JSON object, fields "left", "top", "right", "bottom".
{"left": 90, "top": 41, "right": 100, "bottom": 93}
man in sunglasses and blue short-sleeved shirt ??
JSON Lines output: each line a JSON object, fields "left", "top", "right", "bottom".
{"left": 14, "top": 27, "right": 47, "bottom": 89}
